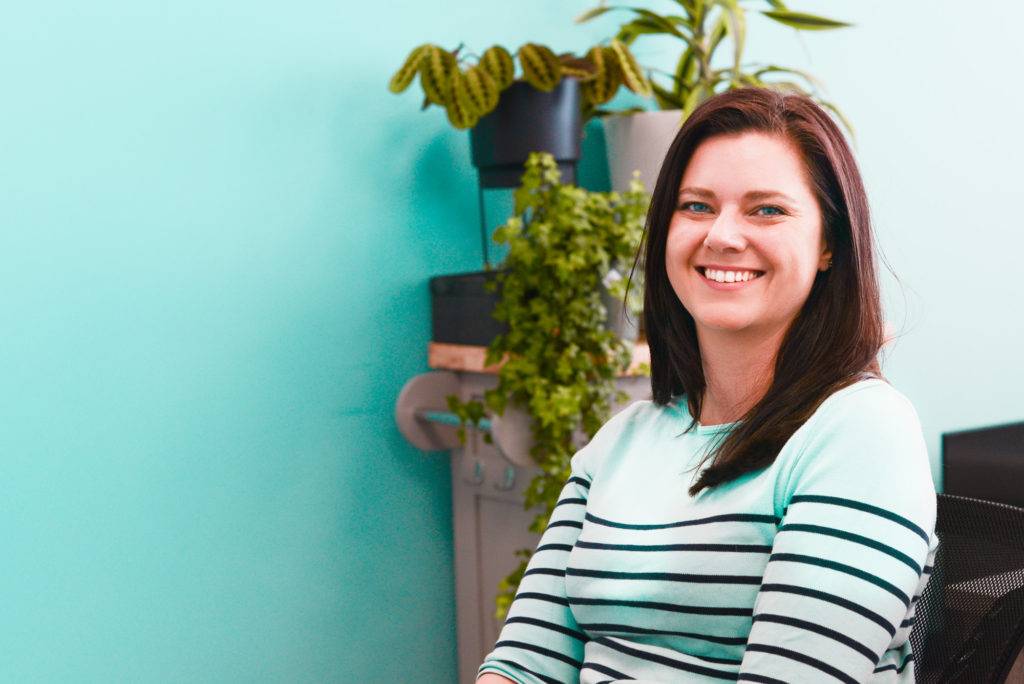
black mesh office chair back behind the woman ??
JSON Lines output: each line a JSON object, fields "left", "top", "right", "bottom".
{"left": 910, "top": 494, "right": 1024, "bottom": 684}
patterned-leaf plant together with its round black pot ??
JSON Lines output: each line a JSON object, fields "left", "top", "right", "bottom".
{"left": 388, "top": 39, "right": 651, "bottom": 187}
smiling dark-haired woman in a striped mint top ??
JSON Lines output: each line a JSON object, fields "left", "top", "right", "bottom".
{"left": 478, "top": 89, "right": 938, "bottom": 684}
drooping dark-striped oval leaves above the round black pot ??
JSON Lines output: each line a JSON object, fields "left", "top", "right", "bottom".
{"left": 388, "top": 39, "right": 652, "bottom": 129}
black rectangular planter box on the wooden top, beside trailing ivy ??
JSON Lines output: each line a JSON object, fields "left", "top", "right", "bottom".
{"left": 430, "top": 270, "right": 508, "bottom": 347}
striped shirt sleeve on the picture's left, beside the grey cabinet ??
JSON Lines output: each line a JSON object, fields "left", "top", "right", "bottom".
{"left": 479, "top": 401, "right": 643, "bottom": 684}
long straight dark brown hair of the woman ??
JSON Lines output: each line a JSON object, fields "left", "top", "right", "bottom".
{"left": 640, "top": 88, "right": 885, "bottom": 496}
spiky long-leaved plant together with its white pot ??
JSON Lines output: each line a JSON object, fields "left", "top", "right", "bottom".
{"left": 577, "top": 0, "right": 853, "bottom": 188}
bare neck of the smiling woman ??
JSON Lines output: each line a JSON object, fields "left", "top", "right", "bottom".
{"left": 697, "top": 328, "right": 785, "bottom": 425}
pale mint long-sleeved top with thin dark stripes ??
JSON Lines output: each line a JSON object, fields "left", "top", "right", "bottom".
{"left": 480, "top": 379, "right": 939, "bottom": 684}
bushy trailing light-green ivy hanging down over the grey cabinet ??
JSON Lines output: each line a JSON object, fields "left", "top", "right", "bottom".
{"left": 449, "top": 154, "right": 649, "bottom": 613}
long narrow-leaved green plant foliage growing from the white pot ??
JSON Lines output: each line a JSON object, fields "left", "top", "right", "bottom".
{"left": 577, "top": 0, "right": 853, "bottom": 134}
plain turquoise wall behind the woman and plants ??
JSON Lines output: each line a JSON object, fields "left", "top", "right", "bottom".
{"left": 0, "top": 0, "right": 1024, "bottom": 682}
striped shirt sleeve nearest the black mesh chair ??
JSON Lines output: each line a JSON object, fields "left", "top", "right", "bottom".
{"left": 738, "top": 383, "right": 936, "bottom": 683}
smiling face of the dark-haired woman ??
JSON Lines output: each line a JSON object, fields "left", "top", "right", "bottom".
{"left": 665, "top": 132, "right": 831, "bottom": 339}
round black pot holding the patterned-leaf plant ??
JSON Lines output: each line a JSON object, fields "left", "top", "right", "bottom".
{"left": 469, "top": 78, "right": 583, "bottom": 187}
